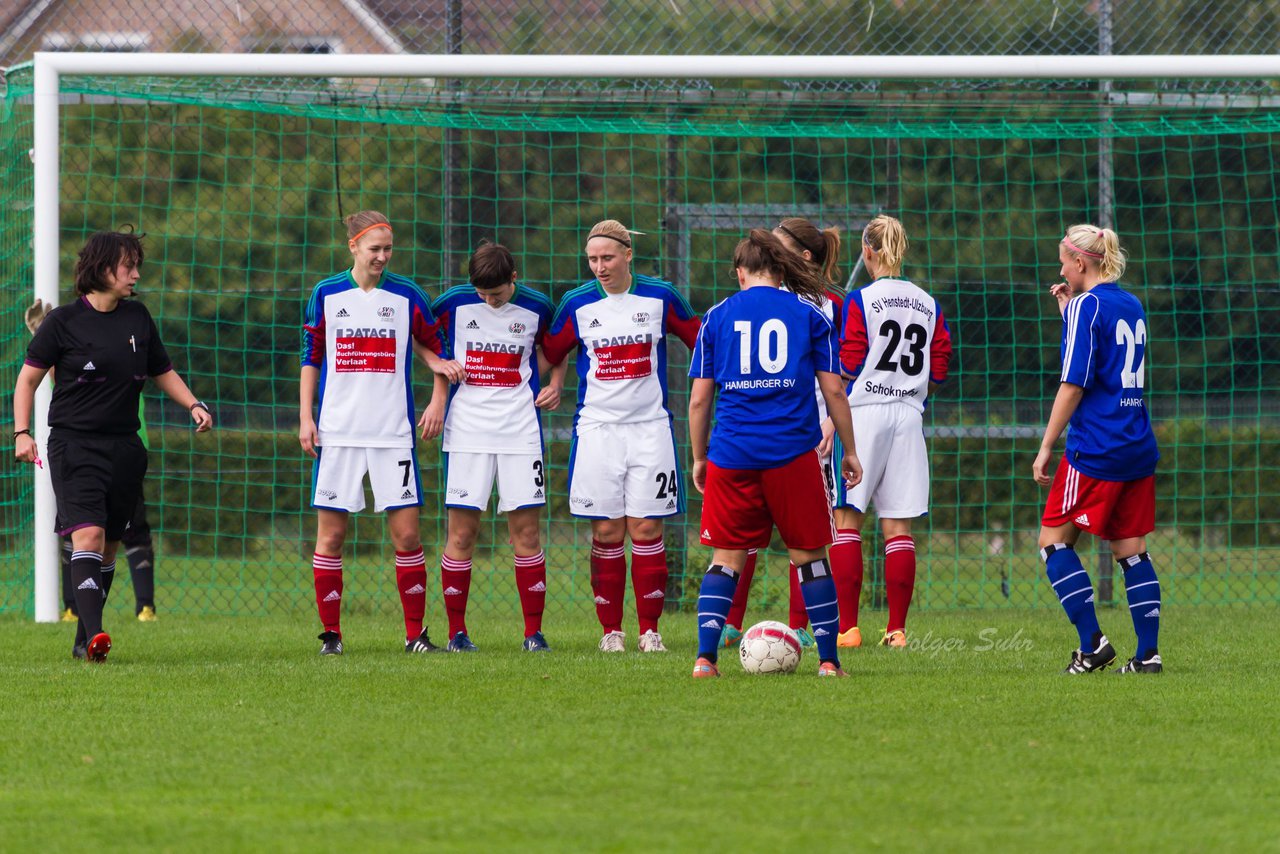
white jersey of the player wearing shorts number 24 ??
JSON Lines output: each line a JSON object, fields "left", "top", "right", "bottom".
{"left": 544, "top": 275, "right": 699, "bottom": 431}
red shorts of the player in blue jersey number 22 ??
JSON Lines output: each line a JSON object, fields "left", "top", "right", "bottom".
{"left": 1041, "top": 457, "right": 1156, "bottom": 540}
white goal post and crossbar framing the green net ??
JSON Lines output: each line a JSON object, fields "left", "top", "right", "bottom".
{"left": 32, "top": 51, "right": 1280, "bottom": 622}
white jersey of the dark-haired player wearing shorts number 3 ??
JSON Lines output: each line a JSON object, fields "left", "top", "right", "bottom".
{"left": 431, "top": 284, "right": 553, "bottom": 455}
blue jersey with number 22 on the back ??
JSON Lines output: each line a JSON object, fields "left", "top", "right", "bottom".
{"left": 1061, "top": 283, "right": 1160, "bottom": 480}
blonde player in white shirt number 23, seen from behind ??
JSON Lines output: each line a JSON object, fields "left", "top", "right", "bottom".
{"left": 831, "top": 214, "right": 951, "bottom": 647}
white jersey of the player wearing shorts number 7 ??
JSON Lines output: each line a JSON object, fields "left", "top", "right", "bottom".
{"left": 302, "top": 271, "right": 440, "bottom": 448}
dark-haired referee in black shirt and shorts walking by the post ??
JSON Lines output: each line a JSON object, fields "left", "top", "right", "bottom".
{"left": 13, "top": 232, "right": 214, "bottom": 662}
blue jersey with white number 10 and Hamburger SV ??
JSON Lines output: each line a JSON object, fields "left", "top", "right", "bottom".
{"left": 689, "top": 287, "right": 840, "bottom": 469}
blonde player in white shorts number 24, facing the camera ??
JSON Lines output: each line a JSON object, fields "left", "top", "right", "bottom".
{"left": 543, "top": 219, "right": 699, "bottom": 653}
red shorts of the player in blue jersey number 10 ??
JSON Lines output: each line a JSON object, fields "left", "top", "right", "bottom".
{"left": 701, "top": 451, "right": 836, "bottom": 549}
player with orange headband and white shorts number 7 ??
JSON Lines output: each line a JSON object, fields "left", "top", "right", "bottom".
{"left": 298, "top": 210, "right": 463, "bottom": 656}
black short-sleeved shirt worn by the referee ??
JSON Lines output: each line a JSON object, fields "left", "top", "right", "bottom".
{"left": 27, "top": 297, "right": 173, "bottom": 435}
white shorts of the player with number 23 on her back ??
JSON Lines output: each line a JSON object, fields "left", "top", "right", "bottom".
{"left": 835, "top": 403, "right": 929, "bottom": 519}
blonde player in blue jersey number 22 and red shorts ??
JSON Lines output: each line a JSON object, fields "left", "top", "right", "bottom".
{"left": 1032, "top": 225, "right": 1164, "bottom": 673}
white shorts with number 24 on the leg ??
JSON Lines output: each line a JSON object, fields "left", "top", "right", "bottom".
{"left": 568, "top": 421, "right": 685, "bottom": 519}
